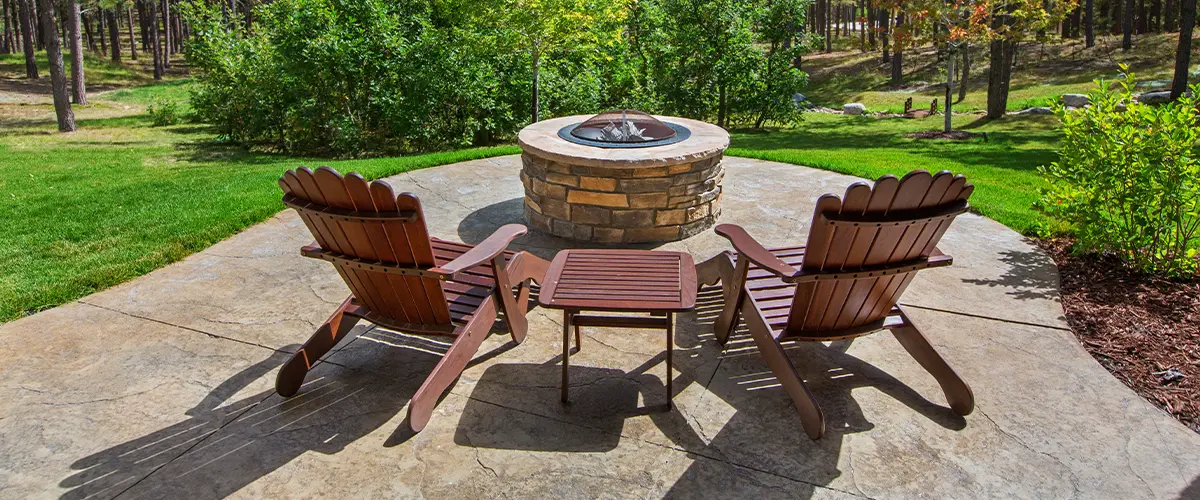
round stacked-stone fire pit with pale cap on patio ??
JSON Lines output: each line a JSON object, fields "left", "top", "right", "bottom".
{"left": 517, "top": 112, "right": 730, "bottom": 243}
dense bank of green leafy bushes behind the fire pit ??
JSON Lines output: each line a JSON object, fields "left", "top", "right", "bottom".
{"left": 181, "top": 0, "right": 806, "bottom": 156}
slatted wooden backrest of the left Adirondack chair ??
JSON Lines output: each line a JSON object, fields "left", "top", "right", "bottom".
{"left": 280, "top": 167, "right": 450, "bottom": 325}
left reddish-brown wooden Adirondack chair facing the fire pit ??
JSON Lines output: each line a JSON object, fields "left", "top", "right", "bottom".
{"left": 275, "top": 167, "right": 548, "bottom": 430}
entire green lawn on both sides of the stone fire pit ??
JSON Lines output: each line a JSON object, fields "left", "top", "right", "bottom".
{"left": 0, "top": 48, "right": 1057, "bottom": 321}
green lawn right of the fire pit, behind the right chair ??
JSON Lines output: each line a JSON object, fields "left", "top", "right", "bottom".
{"left": 727, "top": 113, "right": 1064, "bottom": 234}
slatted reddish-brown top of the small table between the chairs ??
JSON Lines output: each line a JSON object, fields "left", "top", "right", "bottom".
{"left": 538, "top": 249, "right": 696, "bottom": 312}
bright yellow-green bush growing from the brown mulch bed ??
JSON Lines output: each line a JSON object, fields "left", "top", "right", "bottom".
{"left": 1040, "top": 68, "right": 1200, "bottom": 276}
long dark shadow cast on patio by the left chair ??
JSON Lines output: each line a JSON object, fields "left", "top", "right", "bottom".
{"left": 59, "top": 326, "right": 515, "bottom": 499}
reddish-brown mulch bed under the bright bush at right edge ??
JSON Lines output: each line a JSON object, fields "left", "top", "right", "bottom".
{"left": 1039, "top": 239, "right": 1200, "bottom": 432}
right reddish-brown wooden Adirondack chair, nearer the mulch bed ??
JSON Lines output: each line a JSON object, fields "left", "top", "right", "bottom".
{"left": 697, "top": 170, "right": 974, "bottom": 439}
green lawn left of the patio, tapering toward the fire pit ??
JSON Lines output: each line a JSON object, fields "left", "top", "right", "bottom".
{"left": 0, "top": 83, "right": 520, "bottom": 321}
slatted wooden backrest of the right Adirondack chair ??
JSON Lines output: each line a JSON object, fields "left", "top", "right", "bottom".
{"left": 788, "top": 170, "right": 973, "bottom": 332}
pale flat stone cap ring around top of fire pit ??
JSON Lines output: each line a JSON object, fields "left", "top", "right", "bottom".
{"left": 517, "top": 115, "right": 730, "bottom": 168}
